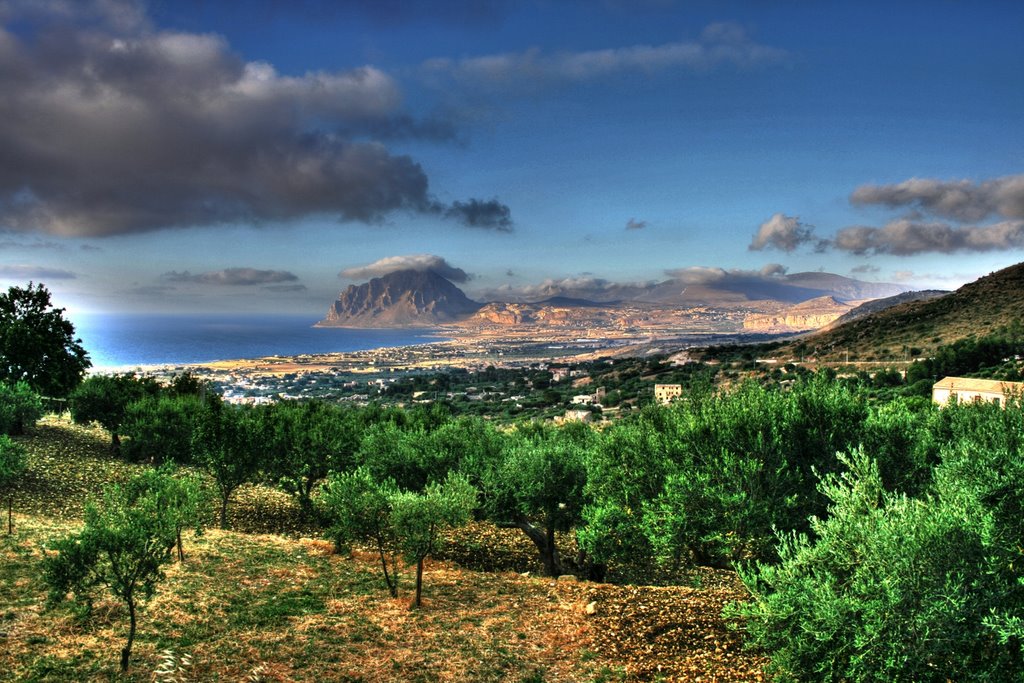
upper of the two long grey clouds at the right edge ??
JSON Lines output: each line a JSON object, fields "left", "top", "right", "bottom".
{"left": 850, "top": 175, "right": 1024, "bottom": 222}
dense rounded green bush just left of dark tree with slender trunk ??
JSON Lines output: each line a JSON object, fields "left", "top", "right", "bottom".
{"left": 121, "top": 395, "right": 205, "bottom": 465}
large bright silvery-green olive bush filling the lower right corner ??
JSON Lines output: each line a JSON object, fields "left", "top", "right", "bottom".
{"left": 737, "top": 452, "right": 1024, "bottom": 681}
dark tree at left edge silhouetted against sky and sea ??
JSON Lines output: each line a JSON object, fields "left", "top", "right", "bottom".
{"left": 0, "top": 283, "right": 92, "bottom": 397}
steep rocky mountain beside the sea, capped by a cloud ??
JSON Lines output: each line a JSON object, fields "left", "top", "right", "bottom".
{"left": 317, "top": 270, "right": 480, "bottom": 328}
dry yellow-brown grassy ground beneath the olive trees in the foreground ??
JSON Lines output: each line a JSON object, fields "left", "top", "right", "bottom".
{"left": 0, "top": 420, "right": 764, "bottom": 681}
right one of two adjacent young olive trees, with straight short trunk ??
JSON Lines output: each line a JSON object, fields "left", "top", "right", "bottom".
{"left": 389, "top": 473, "right": 476, "bottom": 607}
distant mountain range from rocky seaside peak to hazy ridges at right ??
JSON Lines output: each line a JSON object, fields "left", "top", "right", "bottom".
{"left": 317, "top": 270, "right": 906, "bottom": 329}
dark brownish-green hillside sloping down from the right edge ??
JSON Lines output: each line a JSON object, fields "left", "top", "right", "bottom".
{"left": 773, "top": 263, "right": 1024, "bottom": 360}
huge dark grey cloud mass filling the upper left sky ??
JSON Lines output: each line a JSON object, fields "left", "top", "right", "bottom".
{"left": 0, "top": 0, "right": 511, "bottom": 237}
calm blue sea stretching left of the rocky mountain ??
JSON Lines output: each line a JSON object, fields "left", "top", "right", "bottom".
{"left": 69, "top": 314, "right": 438, "bottom": 368}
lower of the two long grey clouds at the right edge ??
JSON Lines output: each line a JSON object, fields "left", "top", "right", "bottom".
{"left": 833, "top": 218, "right": 1024, "bottom": 256}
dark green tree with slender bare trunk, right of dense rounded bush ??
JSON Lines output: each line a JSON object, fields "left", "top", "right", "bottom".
{"left": 193, "top": 401, "right": 266, "bottom": 528}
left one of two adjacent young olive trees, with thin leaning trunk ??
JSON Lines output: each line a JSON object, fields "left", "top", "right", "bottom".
{"left": 317, "top": 467, "right": 398, "bottom": 598}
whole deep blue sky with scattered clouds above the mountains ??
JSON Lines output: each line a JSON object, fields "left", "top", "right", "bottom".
{"left": 0, "top": 0, "right": 1024, "bottom": 319}
